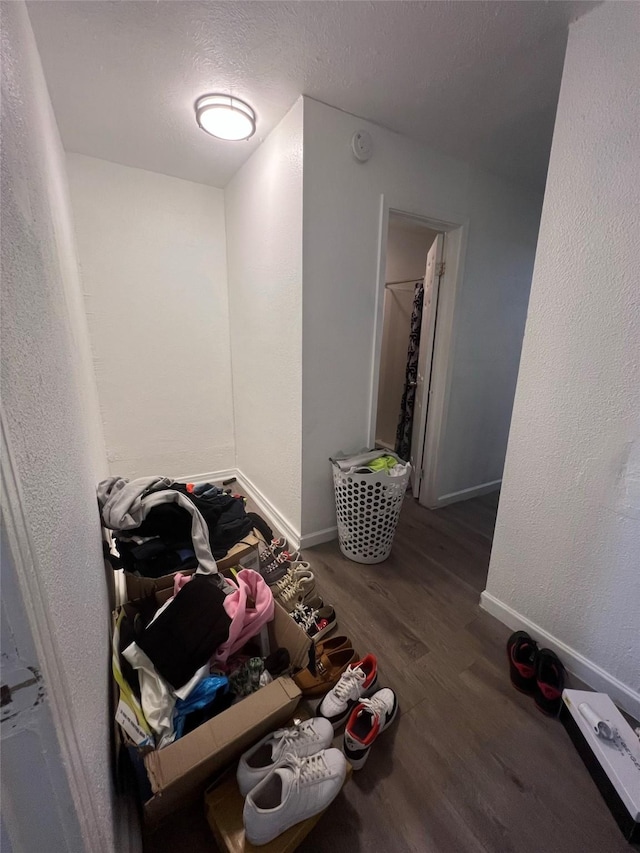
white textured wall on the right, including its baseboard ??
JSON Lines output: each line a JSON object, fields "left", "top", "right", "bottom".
{"left": 484, "top": 3, "right": 640, "bottom": 717}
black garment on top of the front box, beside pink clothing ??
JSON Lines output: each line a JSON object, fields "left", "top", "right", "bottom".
{"left": 138, "top": 572, "right": 231, "bottom": 689}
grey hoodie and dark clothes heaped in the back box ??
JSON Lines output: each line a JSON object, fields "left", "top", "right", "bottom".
{"left": 98, "top": 477, "right": 273, "bottom": 578}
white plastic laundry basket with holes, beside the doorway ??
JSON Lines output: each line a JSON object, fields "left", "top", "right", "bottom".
{"left": 332, "top": 454, "right": 411, "bottom": 563}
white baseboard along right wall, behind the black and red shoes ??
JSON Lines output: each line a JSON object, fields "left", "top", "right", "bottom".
{"left": 480, "top": 590, "right": 640, "bottom": 720}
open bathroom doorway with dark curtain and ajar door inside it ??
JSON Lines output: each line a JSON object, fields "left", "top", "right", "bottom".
{"left": 372, "top": 209, "right": 464, "bottom": 508}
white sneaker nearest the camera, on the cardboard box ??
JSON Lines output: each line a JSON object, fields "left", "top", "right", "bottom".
{"left": 243, "top": 749, "right": 347, "bottom": 844}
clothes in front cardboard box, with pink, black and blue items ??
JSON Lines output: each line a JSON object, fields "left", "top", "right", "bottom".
{"left": 112, "top": 569, "right": 289, "bottom": 748}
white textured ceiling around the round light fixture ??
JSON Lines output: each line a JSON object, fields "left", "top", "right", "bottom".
{"left": 28, "top": 0, "right": 595, "bottom": 187}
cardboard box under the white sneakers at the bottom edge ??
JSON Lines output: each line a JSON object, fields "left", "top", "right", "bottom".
{"left": 204, "top": 762, "right": 352, "bottom": 853}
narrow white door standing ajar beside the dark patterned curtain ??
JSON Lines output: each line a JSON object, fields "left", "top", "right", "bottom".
{"left": 409, "top": 234, "right": 444, "bottom": 499}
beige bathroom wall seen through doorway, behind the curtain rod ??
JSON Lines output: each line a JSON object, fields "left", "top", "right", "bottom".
{"left": 376, "top": 214, "right": 436, "bottom": 447}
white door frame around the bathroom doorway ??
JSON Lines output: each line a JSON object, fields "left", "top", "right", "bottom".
{"left": 367, "top": 195, "right": 469, "bottom": 508}
